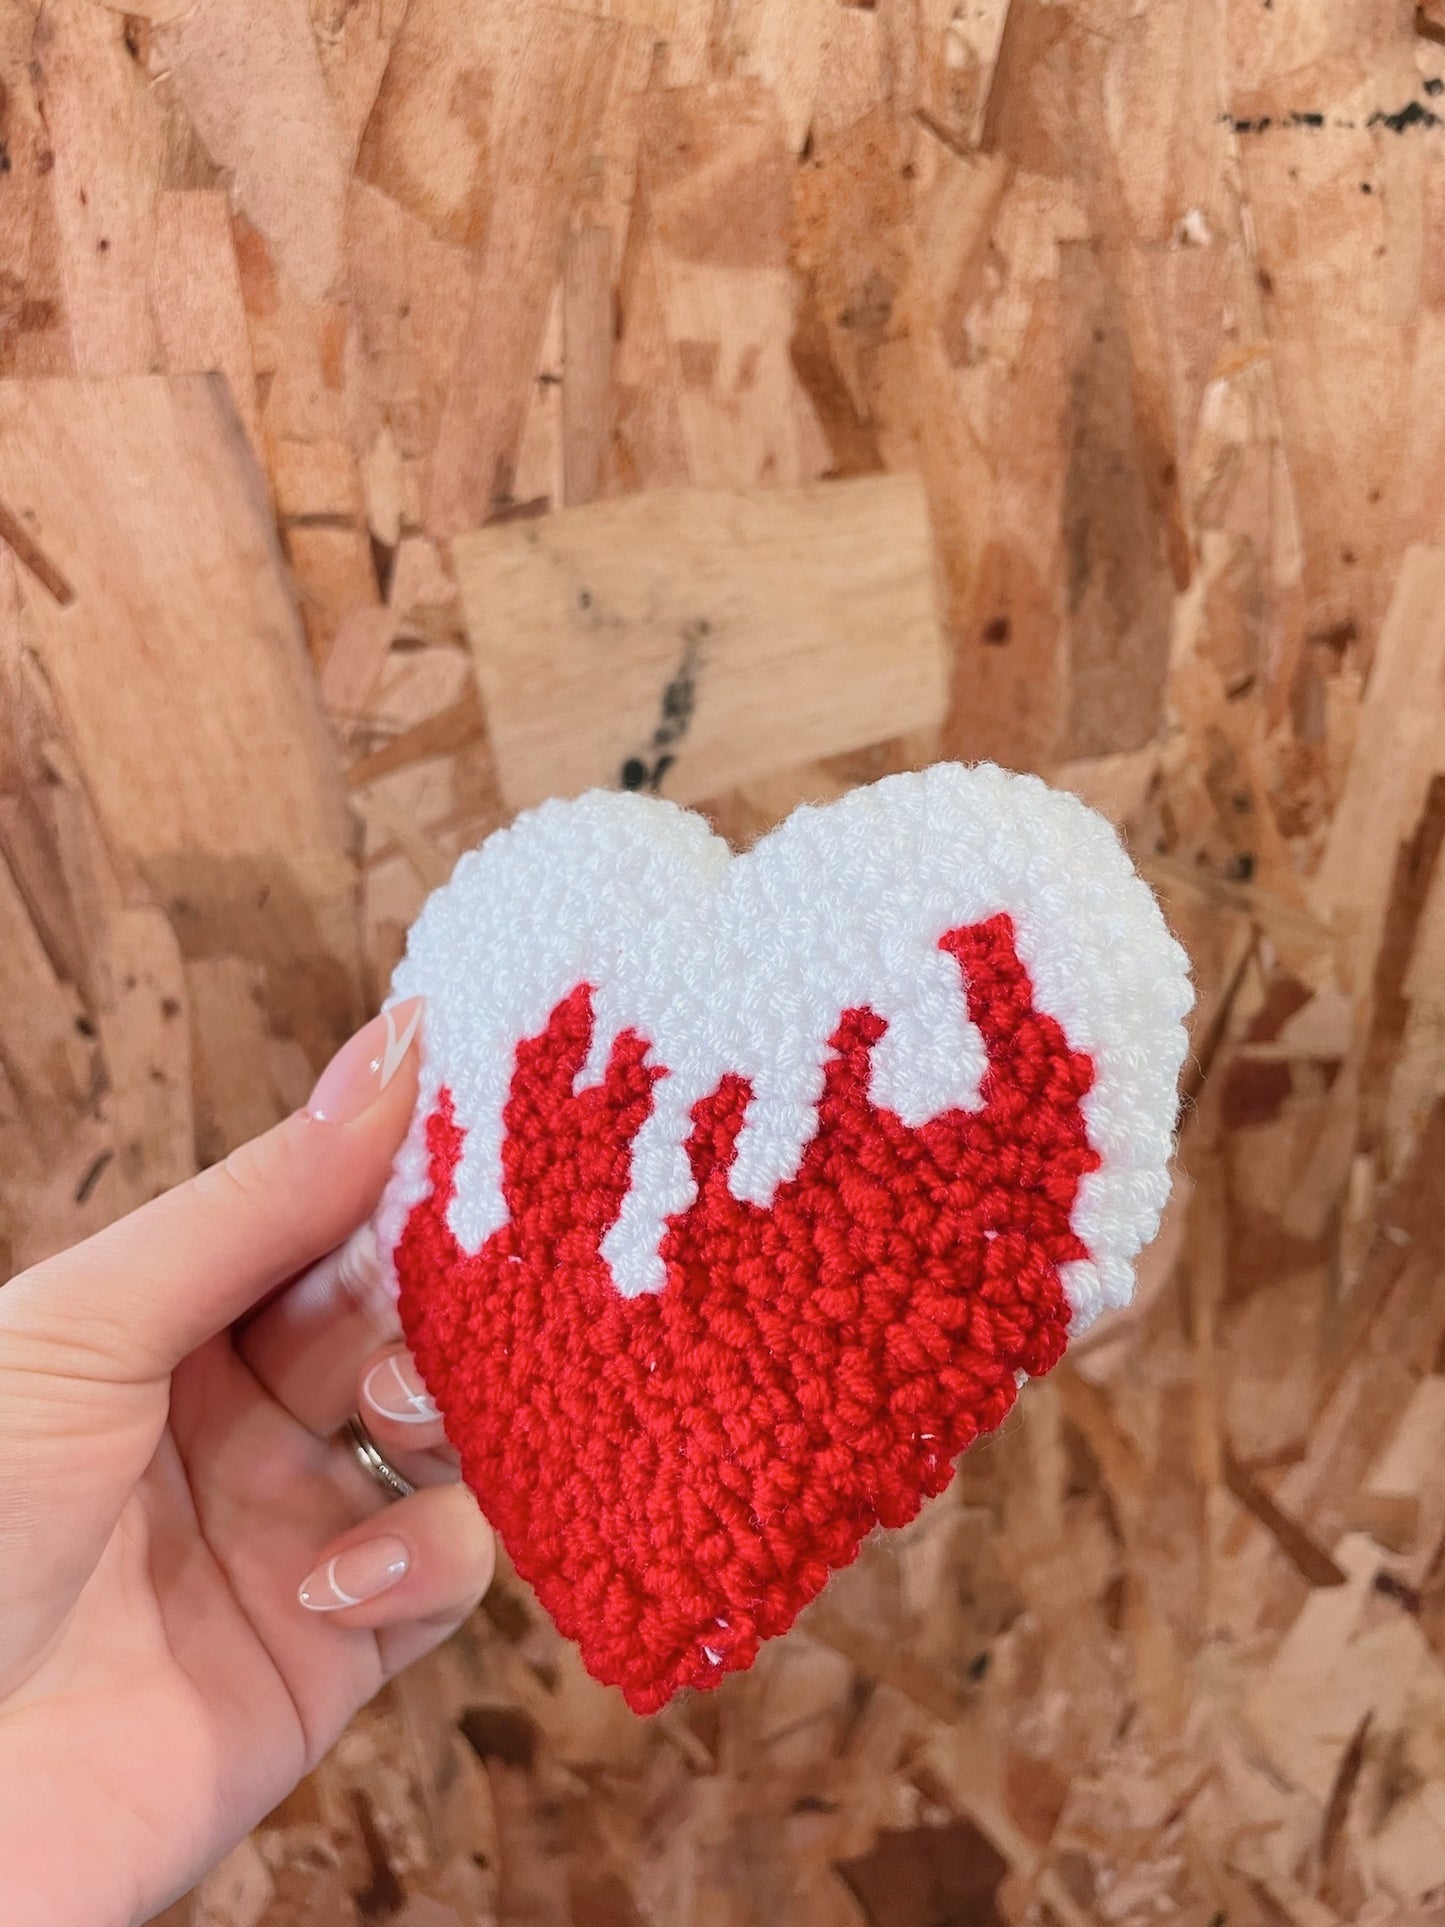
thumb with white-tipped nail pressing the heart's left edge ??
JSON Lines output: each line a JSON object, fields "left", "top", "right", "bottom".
{"left": 0, "top": 998, "right": 422, "bottom": 1690}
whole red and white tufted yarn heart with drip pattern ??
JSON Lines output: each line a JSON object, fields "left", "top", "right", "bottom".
{"left": 378, "top": 763, "right": 1191, "bottom": 1713}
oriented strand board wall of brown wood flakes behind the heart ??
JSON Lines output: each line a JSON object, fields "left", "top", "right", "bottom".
{"left": 0, "top": 0, "right": 1445, "bottom": 1927}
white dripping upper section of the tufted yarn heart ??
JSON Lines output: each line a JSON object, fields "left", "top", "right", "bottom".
{"left": 378, "top": 763, "right": 1191, "bottom": 1332}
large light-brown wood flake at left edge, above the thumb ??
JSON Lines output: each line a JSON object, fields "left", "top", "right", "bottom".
{"left": 0, "top": 376, "right": 358, "bottom": 1054}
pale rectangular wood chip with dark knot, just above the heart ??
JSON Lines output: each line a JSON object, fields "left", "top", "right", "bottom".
{"left": 453, "top": 476, "right": 944, "bottom": 807}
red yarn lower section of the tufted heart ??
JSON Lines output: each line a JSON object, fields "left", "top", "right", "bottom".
{"left": 395, "top": 915, "right": 1100, "bottom": 1713}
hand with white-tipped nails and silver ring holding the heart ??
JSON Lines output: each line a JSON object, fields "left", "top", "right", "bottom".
{"left": 0, "top": 1006, "right": 493, "bottom": 1927}
